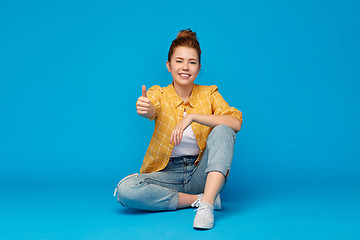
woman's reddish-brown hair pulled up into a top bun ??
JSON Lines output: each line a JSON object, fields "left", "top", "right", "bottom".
{"left": 168, "top": 28, "right": 201, "bottom": 64}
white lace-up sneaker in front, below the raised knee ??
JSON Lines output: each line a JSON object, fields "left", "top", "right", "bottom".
{"left": 193, "top": 202, "right": 214, "bottom": 229}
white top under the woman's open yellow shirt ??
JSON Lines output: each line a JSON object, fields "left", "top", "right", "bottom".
{"left": 171, "top": 111, "right": 200, "bottom": 157}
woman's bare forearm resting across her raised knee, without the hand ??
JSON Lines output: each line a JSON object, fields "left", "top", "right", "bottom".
{"left": 189, "top": 114, "right": 241, "bottom": 132}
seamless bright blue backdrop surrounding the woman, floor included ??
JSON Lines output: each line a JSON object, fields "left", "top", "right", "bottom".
{"left": 0, "top": 0, "right": 360, "bottom": 239}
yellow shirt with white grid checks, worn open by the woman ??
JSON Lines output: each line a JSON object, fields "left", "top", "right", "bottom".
{"left": 140, "top": 84, "right": 242, "bottom": 173}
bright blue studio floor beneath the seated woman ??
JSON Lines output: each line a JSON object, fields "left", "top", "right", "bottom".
{"left": 0, "top": 181, "right": 360, "bottom": 240}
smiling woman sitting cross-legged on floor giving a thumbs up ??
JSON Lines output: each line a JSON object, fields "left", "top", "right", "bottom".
{"left": 115, "top": 29, "right": 242, "bottom": 229}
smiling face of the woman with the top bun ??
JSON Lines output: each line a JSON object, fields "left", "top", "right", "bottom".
{"left": 166, "top": 47, "right": 201, "bottom": 86}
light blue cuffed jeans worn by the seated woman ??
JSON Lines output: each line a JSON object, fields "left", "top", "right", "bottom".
{"left": 116, "top": 125, "right": 236, "bottom": 211}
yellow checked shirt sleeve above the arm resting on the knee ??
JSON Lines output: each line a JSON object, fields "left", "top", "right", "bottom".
{"left": 210, "top": 85, "right": 242, "bottom": 123}
